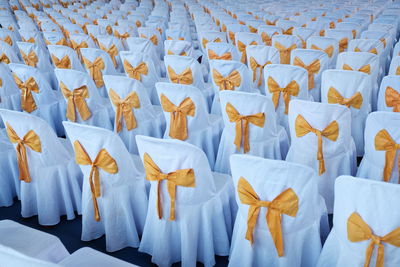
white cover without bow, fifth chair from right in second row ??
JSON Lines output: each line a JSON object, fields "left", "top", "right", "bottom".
{"left": 103, "top": 75, "right": 165, "bottom": 154}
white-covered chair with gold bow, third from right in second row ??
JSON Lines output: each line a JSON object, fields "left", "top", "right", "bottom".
{"left": 215, "top": 91, "right": 289, "bottom": 174}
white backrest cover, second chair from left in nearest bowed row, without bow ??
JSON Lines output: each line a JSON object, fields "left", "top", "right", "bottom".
{"left": 63, "top": 121, "right": 144, "bottom": 187}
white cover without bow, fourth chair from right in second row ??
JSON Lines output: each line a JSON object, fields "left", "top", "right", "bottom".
{"left": 156, "top": 83, "right": 223, "bottom": 169}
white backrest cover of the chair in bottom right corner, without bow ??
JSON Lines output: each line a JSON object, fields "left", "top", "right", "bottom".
{"left": 333, "top": 176, "right": 400, "bottom": 266}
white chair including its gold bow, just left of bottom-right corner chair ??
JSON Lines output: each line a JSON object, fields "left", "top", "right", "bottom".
{"left": 229, "top": 155, "right": 328, "bottom": 266}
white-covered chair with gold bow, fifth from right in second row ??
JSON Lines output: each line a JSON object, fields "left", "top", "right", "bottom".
{"left": 103, "top": 75, "right": 165, "bottom": 154}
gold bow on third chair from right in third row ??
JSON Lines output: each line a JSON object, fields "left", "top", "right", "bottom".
{"left": 267, "top": 76, "right": 300, "bottom": 114}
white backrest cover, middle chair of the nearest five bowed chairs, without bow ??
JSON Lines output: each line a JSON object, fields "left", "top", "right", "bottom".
{"left": 136, "top": 136, "right": 216, "bottom": 207}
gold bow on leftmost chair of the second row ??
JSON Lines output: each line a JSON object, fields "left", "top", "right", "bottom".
{"left": 13, "top": 75, "right": 39, "bottom": 113}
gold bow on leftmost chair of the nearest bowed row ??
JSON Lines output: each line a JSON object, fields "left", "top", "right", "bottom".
{"left": 6, "top": 122, "right": 42, "bottom": 183}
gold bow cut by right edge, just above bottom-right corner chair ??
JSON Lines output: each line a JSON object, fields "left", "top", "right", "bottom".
{"left": 375, "top": 130, "right": 400, "bottom": 182}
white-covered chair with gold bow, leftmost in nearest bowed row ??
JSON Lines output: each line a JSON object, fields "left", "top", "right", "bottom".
{"left": 0, "top": 110, "right": 82, "bottom": 225}
